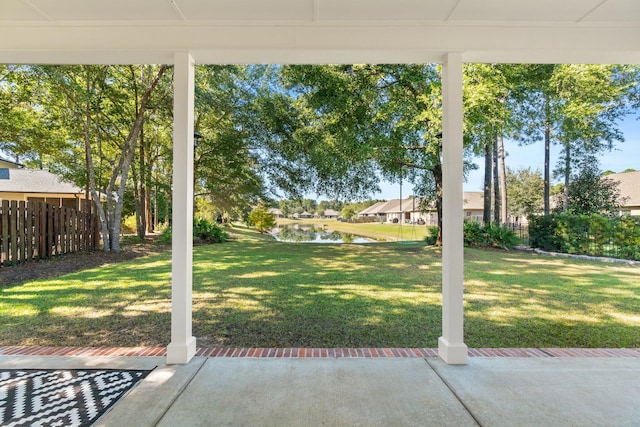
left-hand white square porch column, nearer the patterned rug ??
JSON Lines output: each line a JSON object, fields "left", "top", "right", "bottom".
{"left": 167, "top": 52, "right": 196, "bottom": 364}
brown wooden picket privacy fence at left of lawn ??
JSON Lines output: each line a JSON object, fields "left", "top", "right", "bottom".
{"left": 0, "top": 200, "right": 100, "bottom": 267}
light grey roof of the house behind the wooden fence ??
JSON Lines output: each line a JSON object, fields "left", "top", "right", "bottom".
{"left": 0, "top": 169, "right": 83, "bottom": 194}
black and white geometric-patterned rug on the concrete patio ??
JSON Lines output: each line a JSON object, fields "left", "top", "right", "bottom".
{"left": 0, "top": 369, "right": 151, "bottom": 427}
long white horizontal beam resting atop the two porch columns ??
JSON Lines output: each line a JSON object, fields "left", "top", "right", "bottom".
{"left": 0, "top": 23, "right": 640, "bottom": 63}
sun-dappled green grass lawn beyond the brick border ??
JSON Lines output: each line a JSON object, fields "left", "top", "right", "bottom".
{"left": 0, "top": 229, "right": 640, "bottom": 347}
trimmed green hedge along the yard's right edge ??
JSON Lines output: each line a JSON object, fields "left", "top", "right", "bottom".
{"left": 529, "top": 213, "right": 640, "bottom": 260}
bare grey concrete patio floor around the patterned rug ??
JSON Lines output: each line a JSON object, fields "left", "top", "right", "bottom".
{"left": 0, "top": 355, "right": 640, "bottom": 426}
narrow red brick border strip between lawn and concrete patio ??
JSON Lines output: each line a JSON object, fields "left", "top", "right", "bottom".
{"left": 0, "top": 346, "right": 640, "bottom": 358}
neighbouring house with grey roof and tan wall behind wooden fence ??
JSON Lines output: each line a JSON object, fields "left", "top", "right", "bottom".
{"left": 0, "top": 167, "right": 85, "bottom": 209}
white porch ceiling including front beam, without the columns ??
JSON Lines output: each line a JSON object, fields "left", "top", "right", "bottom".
{"left": 0, "top": 0, "right": 640, "bottom": 63}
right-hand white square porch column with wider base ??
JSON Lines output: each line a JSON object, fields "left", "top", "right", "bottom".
{"left": 438, "top": 53, "right": 467, "bottom": 365}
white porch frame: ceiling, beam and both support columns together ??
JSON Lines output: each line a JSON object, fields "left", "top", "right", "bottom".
{"left": 0, "top": 0, "right": 640, "bottom": 364}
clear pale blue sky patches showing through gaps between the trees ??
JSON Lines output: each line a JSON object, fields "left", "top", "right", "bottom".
{"left": 373, "top": 112, "right": 640, "bottom": 199}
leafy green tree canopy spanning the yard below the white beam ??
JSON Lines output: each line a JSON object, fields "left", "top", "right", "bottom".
{"left": 0, "top": 64, "right": 640, "bottom": 250}
